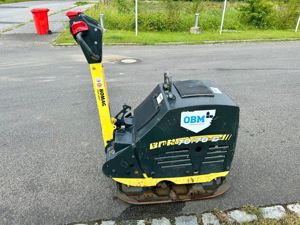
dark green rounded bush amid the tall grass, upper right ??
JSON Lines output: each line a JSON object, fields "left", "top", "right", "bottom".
{"left": 240, "top": 0, "right": 274, "bottom": 29}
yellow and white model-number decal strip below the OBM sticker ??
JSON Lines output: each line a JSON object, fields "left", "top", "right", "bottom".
{"left": 149, "top": 134, "right": 232, "bottom": 150}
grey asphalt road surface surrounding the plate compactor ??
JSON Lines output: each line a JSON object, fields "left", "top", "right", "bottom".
{"left": 0, "top": 35, "right": 300, "bottom": 225}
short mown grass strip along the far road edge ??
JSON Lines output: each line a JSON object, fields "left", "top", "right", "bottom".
{"left": 54, "top": 29, "right": 300, "bottom": 45}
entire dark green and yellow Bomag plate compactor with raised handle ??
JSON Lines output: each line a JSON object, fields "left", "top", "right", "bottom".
{"left": 67, "top": 11, "right": 239, "bottom": 204}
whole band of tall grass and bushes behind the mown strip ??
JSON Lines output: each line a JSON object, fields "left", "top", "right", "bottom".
{"left": 86, "top": 0, "right": 300, "bottom": 32}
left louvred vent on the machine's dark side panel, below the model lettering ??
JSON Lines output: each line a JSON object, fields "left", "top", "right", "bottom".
{"left": 154, "top": 148, "right": 192, "bottom": 169}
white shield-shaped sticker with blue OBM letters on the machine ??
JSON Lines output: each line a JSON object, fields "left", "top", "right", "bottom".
{"left": 180, "top": 109, "right": 216, "bottom": 133}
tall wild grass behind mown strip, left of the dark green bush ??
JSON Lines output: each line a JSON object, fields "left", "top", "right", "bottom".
{"left": 85, "top": 0, "right": 247, "bottom": 32}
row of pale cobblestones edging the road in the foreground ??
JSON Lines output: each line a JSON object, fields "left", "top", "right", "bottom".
{"left": 67, "top": 203, "right": 300, "bottom": 225}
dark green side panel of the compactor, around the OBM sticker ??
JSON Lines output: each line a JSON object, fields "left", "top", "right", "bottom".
{"left": 137, "top": 106, "right": 239, "bottom": 178}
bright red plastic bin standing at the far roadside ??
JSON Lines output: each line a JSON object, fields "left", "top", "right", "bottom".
{"left": 31, "top": 8, "right": 49, "bottom": 35}
